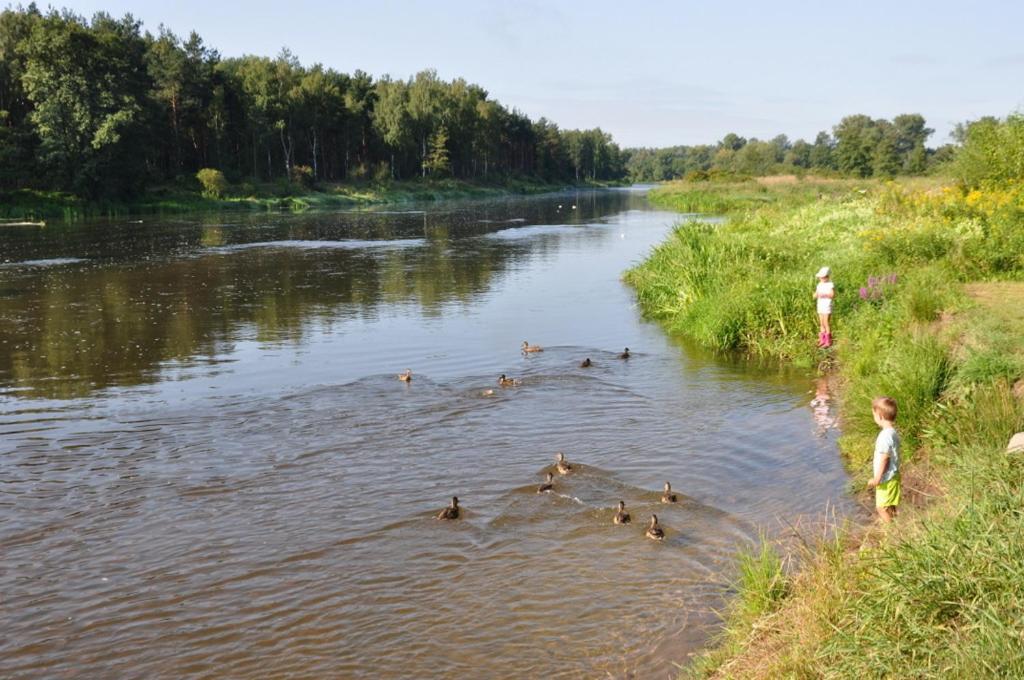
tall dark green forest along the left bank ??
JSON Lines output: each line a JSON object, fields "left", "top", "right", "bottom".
{"left": 0, "top": 4, "right": 626, "bottom": 197}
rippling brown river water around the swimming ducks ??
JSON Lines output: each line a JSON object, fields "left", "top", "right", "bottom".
{"left": 0, "top": 190, "right": 851, "bottom": 678}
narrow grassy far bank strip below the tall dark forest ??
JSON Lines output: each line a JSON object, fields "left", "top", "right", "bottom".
{"left": 0, "top": 178, "right": 609, "bottom": 220}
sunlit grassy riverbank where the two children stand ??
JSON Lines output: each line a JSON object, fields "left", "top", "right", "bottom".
{"left": 627, "top": 180, "right": 1024, "bottom": 678}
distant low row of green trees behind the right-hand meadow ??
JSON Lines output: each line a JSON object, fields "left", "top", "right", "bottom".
{"left": 627, "top": 114, "right": 953, "bottom": 181}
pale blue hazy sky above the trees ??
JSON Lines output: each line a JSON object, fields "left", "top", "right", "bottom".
{"left": 46, "top": 0, "right": 1024, "bottom": 146}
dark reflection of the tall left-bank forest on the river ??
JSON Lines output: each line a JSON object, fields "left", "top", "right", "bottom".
{"left": 0, "top": 192, "right": 637, "bottom": 398}
